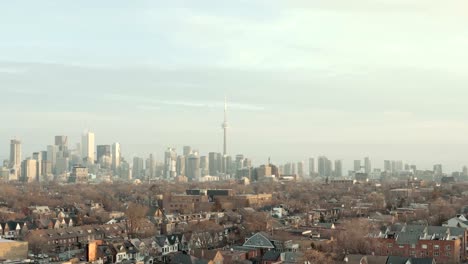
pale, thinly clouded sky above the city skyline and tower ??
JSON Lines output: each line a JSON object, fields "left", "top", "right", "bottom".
{"left": 0, "top": 0, "right": 468, "bottom": 170}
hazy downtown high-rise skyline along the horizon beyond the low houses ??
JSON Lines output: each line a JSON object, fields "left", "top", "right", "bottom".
{"left": 0, "top": 135, "right": 468, "bottom": 183}
